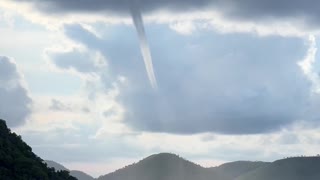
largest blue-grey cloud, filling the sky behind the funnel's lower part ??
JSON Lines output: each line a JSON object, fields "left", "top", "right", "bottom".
{"left": 58, "top": 24, "right": 310, "bottom": 134}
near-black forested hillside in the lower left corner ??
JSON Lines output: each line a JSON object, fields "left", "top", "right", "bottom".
{"left": 0, "top": 119, "right": 76, "bottom": 180}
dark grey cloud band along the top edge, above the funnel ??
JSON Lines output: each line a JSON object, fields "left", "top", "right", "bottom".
{"left": 16, "top": 0, "right": 320, "bottom": 26}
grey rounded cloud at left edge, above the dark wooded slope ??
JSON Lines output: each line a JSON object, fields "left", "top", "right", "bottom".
{"left": 0, "top": 56, "right": 32, "bottom": 127}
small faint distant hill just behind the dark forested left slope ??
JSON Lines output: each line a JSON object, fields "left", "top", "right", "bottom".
{"left": 45, "top": 160, "right": 94, "bottom": 180}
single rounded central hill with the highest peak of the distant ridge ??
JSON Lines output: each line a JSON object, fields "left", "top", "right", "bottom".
{"left": 98, "top": 153, "right": 222, "bottom": 180}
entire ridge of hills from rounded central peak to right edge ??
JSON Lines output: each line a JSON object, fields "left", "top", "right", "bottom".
{"left": 97, "top": 153, "right": 320, "bottom": 180}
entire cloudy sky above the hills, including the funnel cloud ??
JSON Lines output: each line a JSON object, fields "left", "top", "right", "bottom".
{"left": 0, "top": 0, "right": 320, "bottom": 177}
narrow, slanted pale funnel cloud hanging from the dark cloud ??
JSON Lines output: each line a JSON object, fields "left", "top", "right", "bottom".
{"left": 131, "top": 5, "right": 158, "bottom": 89}
